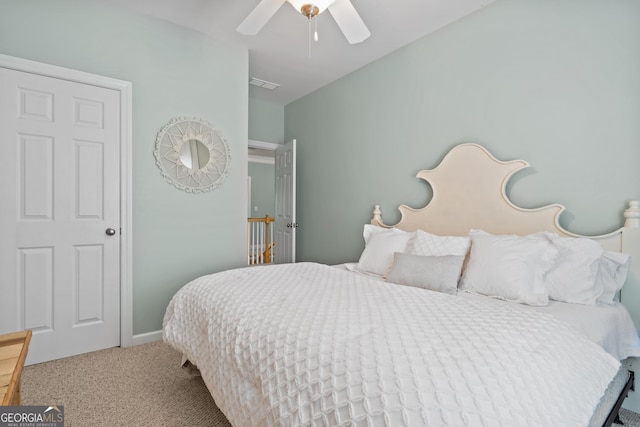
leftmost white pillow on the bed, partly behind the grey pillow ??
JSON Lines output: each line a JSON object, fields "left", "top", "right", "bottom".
{"left": 356, "top": 224, "right": 412, "bottom": 276}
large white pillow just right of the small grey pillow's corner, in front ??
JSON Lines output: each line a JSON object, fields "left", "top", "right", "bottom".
{"left": 460, "top": 230, "right": 558, "bottom": 306}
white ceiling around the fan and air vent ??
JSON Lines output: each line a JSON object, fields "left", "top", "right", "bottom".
{"left": 103, "top": 0, "right": 495, "bottom": 105}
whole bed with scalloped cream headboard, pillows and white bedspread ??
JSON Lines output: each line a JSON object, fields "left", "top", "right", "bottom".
{"left": 163, "top": 144, "right": 640, "bottom": 427}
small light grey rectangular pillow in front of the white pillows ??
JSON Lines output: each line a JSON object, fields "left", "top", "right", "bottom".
{"left": 387, "top": 252, "right": 464, "bottom": 295}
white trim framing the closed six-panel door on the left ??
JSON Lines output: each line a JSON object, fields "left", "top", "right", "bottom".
{"left": 0, "top": 54, "right": 133, "bottom": 347}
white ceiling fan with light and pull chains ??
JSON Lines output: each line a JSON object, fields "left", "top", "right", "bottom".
{"left": 236, "top": 0, "right": 371, "bottom": 44}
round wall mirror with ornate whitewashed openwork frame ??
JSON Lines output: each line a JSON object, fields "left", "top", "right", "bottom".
{"left": 153, "top": 117, "right": 231, "bottom": 193}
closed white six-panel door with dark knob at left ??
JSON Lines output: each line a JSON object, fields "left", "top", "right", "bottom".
{"left": 0, "top": 68, "right": 121, "bottom": 364}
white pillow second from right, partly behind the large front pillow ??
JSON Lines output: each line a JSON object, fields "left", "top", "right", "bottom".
{"left": 541, "top": 233, "right": 604, "bottom": 305}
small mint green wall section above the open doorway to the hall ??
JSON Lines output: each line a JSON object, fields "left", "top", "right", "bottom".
{"left": 249, "top": 97, "right": 284, "bottom": 144}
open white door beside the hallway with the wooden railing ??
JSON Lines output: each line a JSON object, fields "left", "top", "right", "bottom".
{"left": 274, "top": 139, "right": 298, "bottom": 264}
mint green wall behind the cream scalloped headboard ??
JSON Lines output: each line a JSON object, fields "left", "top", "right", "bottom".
{"left": 285, "top": 0, "right": 640, "bottom": 263}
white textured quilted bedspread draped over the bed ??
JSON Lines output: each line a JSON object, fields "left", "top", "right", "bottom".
{"left": 164, "top": 263, "right": 619, "bottom": 427}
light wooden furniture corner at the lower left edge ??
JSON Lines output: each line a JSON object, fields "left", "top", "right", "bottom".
{"left": 0, "top": 330, "right": 31, "bottom": 406}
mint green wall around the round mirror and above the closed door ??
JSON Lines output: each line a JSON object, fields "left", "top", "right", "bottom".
{"left": 0, "top": 0, "right": 248, "bottom": 334}
